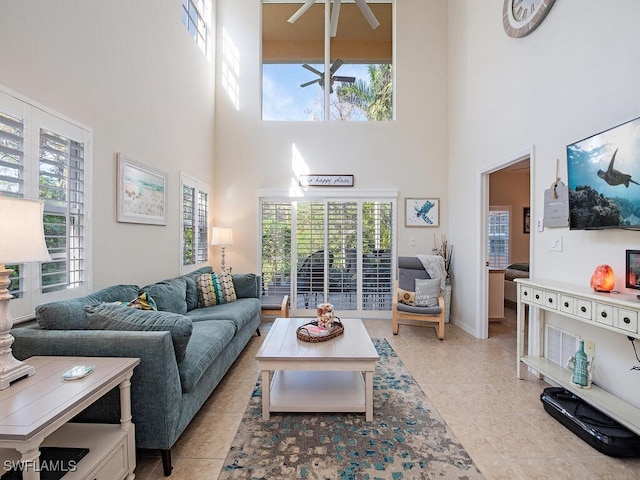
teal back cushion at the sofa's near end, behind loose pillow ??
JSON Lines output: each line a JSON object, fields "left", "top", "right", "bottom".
{"left": 36, "top": 285, "right": 138, "bottom": 330}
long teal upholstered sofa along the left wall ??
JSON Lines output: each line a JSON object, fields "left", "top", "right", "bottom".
{"left": 12, "top": 267, "right": 261, "bottom": 476}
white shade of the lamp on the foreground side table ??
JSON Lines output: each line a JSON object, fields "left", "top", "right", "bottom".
{"left": 0, "top": 196, "right": 51, "bottom": 264}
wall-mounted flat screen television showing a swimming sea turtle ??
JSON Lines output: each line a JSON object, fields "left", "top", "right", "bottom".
{"left": 567, "top": 118, "right": 640, "bottom": 230}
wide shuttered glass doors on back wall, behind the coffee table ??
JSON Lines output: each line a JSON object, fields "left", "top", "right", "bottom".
{"left": 260, "top": 191, "right": 395, "bottom": 317}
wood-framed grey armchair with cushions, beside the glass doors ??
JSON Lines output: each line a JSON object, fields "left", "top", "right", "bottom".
{"left": 392, "top": 257, "right": 445, "bottom": 340}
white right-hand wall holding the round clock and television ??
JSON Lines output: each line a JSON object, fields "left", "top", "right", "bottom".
{"left": 449, "top": 0, "right": 640, "bottom": 406}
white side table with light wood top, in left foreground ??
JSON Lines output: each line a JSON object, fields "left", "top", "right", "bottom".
{"left": 0, "top": 357, "right": 140, "bottom": 480}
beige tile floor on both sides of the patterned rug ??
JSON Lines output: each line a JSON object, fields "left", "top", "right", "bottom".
{"left": 136, "top": 309, "right": 640, "bottom": 480}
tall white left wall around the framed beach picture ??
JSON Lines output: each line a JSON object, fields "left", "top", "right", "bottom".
{"left": 0, "top": 0, "right": 214, "bottom": 288}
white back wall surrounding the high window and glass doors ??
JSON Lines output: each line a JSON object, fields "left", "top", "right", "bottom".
{"left": 215, "top": 0, "right": 449, "bottom": 278}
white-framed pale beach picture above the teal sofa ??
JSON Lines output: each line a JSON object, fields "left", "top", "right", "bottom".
{"left": 116, "top": 153, "right": 167, "bottom": 225}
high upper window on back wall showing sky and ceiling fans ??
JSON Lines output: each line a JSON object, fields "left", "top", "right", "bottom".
{"left": 262, "top": 0, "right": 393, "bottom": 121}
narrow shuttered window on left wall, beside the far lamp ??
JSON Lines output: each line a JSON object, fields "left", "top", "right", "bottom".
{"left": 180, "top": 174, "right": 209, "bottom": 267}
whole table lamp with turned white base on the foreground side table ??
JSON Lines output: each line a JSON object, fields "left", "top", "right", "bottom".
{"left": 0, "top": 195, "right": 51, "bottom": 390}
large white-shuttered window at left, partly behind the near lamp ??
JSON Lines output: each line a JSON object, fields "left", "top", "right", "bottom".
{"left": 0, "top": 88, "right": 92, "bottom": 320}
